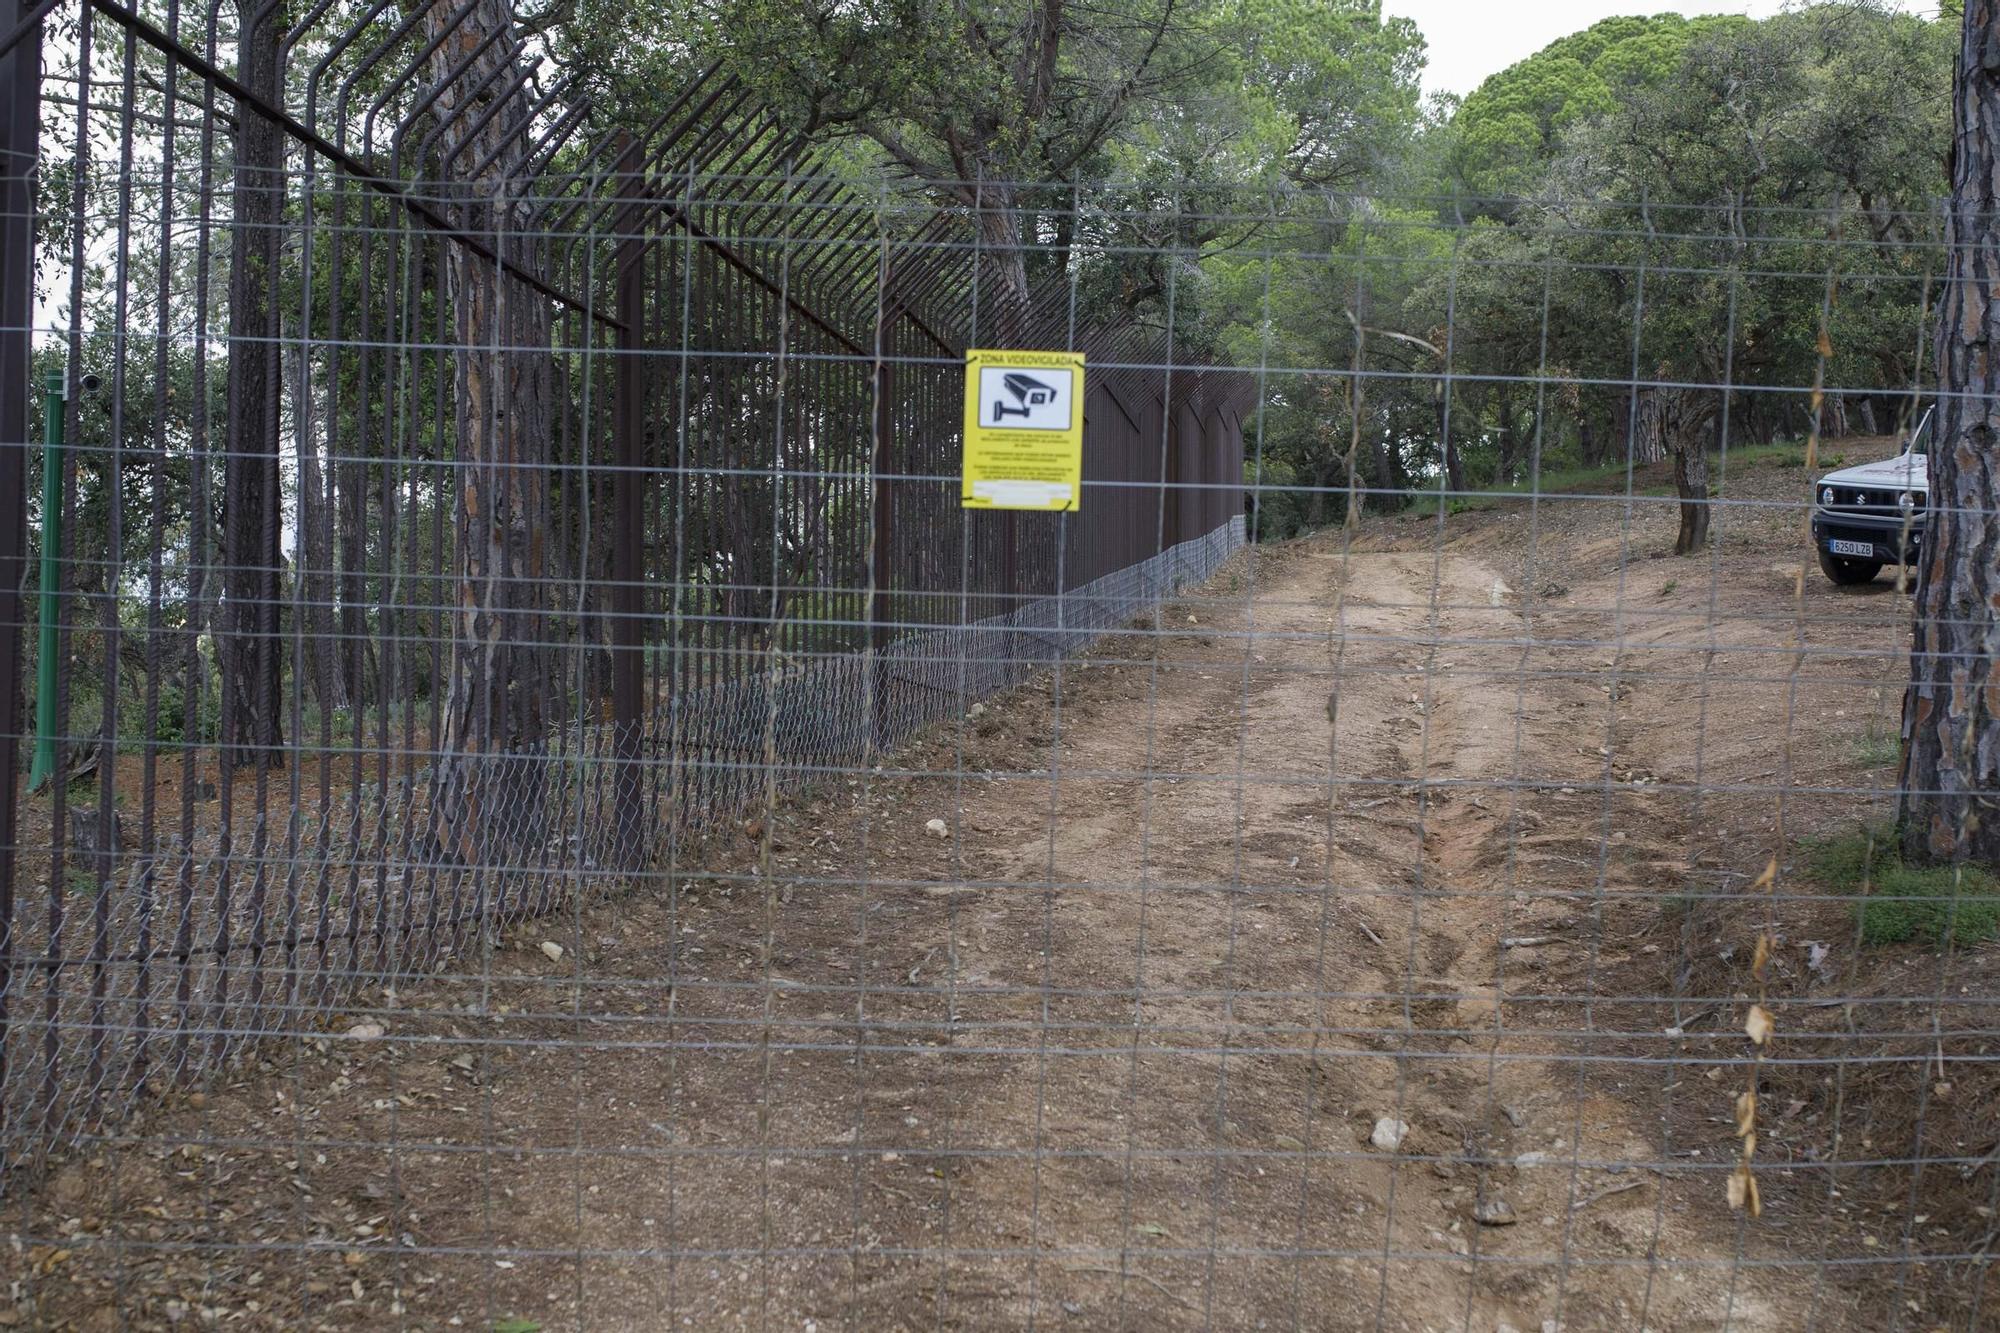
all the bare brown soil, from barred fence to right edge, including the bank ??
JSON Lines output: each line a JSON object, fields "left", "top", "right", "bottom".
{"left": 11, "top": 450, "right": 1994, "bottom": 1333}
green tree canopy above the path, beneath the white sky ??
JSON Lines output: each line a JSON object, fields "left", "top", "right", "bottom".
{"left": 536, "top": 0, "right": 1956, "bottom": 530}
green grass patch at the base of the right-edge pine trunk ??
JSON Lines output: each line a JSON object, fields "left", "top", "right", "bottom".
{"left": 1808, "top": 829, "right": 2000, "bottom": 945}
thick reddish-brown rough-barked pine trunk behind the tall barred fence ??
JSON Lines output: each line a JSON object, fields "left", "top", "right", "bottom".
{"left": 428, "top": 0, "right": 554, "bottom": 867}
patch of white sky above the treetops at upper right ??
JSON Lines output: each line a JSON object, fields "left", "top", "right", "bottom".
{"left": 1382, "top": 0, "right": 1816, "bottom": 96}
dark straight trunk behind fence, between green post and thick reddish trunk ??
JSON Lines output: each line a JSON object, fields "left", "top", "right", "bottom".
{"left": 216, "top": 0, "right": 284, "bottom": 769}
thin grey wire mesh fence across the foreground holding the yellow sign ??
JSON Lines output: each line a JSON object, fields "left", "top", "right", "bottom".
{"left": 0, "top": 0, "right": 2000, "bottom": 1333}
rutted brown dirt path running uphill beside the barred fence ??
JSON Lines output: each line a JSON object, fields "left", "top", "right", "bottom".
{"left": 22, "top": 532, "right": 1844, "bottom": 1333}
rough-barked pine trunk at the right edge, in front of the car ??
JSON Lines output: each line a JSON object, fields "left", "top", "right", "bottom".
{"left": 1900, "top": 0, "right": 2000, "bottom": 865}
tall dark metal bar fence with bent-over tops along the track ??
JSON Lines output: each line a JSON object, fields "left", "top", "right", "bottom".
{"left": 0, "top": 0, "right": 1254, "bottom": 1165}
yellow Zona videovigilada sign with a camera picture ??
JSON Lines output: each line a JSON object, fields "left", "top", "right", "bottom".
{"left": 960, "top": 350, "right": 1084, "bottom": 510}
